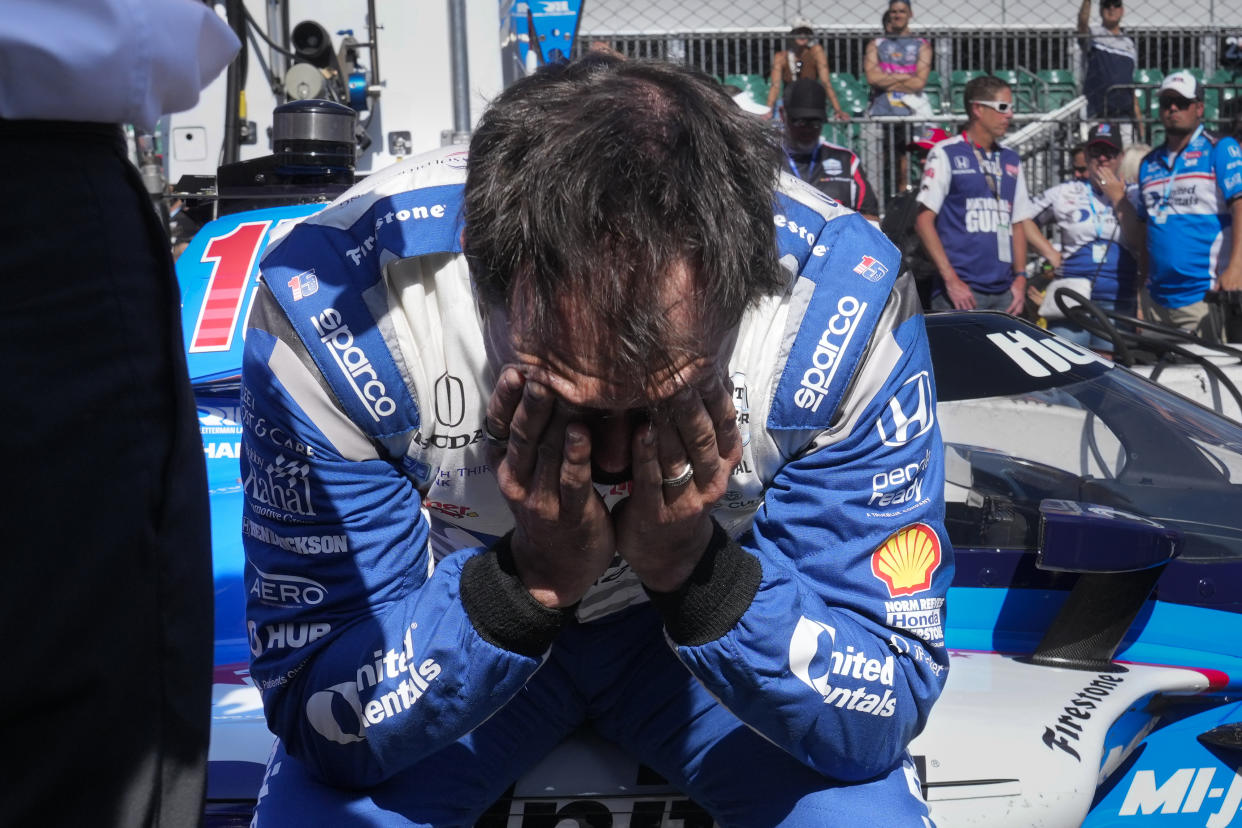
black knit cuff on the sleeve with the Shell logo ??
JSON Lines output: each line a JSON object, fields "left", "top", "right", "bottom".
{"left": 647, "top": 520, "right": 763, "bottom": 647}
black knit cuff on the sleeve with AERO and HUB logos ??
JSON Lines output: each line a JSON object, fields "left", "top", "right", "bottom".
{"left": 461, "top": 533, "right": 573, "bottom": 658}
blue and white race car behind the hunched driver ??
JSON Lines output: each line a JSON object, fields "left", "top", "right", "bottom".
{"left": 178, "top": 204, "right": 1242, "bottom": 828}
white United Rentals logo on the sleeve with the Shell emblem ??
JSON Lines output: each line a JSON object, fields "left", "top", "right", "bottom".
{"left": 789, "top": 616, "right": 897, "bottom": 719}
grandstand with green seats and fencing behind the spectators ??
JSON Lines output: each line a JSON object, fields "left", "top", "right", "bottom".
{"left": 579, "top": 0, "right": 1242, "bottom": 211}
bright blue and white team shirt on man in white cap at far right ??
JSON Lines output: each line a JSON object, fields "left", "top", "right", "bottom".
{"left": 1139, "top": 130, "right": 1242, "bottom": 308}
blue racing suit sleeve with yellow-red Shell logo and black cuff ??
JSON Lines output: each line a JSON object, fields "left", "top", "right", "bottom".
{"left": 652, "top": 278, "right": 953, "bottom": 781}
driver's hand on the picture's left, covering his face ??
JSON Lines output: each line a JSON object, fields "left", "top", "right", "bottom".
{"left": 486, "top": 366, "right": 616, "bottom": 607}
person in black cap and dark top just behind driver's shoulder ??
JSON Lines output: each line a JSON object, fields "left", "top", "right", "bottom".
{"left": 784, "top": 78, "right": 879, "bottom": 225}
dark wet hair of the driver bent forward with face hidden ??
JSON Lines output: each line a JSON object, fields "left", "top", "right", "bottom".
{"left": 463, "top": 55, "right": 786, "bottom": 397}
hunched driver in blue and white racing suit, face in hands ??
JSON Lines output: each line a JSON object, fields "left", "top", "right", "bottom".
{"left": 242, "top": 58, "right": 953, "bottom": 827}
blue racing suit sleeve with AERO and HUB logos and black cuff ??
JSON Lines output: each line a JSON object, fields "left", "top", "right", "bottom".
{"left": 241, "top": 289, "right": 564, "bottom": 787}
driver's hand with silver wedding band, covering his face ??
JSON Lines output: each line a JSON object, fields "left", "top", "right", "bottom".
{"left": 614, "top": 377, "right": 741, "bottom": 592}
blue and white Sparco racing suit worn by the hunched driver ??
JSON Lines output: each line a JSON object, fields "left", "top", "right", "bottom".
{"left": 241, "top": 145, "right": 953, "bottom": 826}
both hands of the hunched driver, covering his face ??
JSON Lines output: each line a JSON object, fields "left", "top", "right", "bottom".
{"left": 487, "top": 366, "right": 741, "bottom": 607}
